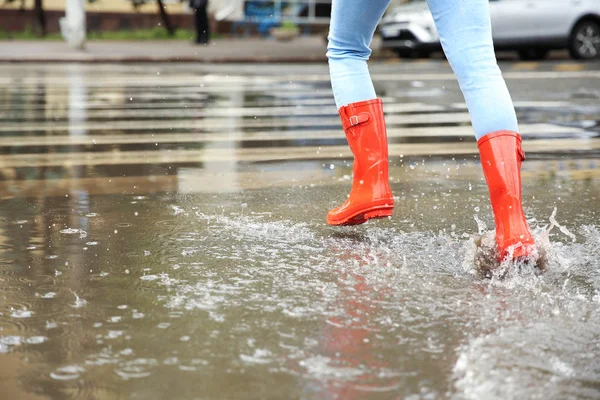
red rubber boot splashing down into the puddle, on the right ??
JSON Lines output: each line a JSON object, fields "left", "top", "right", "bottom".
{"left": 477, "top": 131, "right": 537, "bottom": 260}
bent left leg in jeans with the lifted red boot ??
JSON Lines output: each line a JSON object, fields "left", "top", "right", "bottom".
{"left": 327, "top": 0, "right": 394, "bottom": 225}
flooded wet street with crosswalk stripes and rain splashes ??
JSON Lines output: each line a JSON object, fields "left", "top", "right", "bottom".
{"left": 0, "top": 62, "right": 600, "bottom": 399}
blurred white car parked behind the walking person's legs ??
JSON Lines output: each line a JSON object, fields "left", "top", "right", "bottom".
{"left": 379, "top": 0, "right": 600, "bottom": 60}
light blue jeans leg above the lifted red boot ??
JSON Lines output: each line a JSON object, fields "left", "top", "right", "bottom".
{"left": 327, "top": 0, "right": 390, "bottom": 109}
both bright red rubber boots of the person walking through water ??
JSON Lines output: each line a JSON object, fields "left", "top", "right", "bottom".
{"left": 327, "top": 99, "right": 536, "bottom": 259}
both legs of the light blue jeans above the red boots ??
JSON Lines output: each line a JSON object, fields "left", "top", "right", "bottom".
{"left": 327, "top": 0, "right": 518, "bottom": 139}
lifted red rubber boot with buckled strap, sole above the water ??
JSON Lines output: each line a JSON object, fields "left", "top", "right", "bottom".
{"left": 327, "top": 99, "right": 394, "bottom": 225}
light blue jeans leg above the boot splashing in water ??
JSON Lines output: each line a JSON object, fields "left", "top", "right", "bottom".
{"left": 427, "top": 0, "right": 518, "bottom": 139}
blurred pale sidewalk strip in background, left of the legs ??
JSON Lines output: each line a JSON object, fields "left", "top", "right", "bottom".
{"left": 0, "top": 36, "right": 356, "bottom": 63}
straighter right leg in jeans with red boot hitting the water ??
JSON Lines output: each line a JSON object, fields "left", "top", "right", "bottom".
{"left": 428, "top": 0, "right": 537, "bottom": 259}
